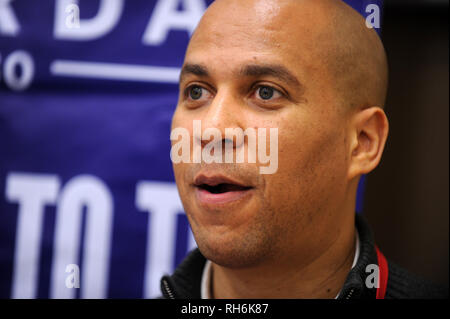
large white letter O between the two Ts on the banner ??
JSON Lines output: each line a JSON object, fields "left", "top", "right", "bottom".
{"left": 50, "top": 175, "right": 113, "bottom": 298}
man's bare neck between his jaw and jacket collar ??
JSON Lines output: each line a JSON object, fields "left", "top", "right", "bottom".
{"left": 211, "top": 215, "right": 355, "bottom": 299}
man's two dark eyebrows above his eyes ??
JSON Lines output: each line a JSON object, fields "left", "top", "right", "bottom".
{"left": 180, "top": 63, "right": 301, "bottom": 86}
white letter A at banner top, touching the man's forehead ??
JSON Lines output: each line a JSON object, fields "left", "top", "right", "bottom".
{"left": 142, "top": 0, "right": 206, "bottom": 45}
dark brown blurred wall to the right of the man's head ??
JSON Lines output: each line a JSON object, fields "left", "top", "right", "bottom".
{"left": 364, "top": 0, "right": 449, "bottom": 286}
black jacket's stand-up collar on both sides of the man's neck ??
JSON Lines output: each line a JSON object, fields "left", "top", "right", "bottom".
{"left": 161, "top": 214, "right": 378, "bottom": 299}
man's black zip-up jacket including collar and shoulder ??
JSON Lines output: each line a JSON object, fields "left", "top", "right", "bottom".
{"left": 161, "top": 214, "right": 448, "bottom": 299}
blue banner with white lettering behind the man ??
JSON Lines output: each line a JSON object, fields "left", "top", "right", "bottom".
{"left": 0, "top": 0, "right": 381, "bottom": 298}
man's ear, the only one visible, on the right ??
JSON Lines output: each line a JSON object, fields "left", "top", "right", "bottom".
{"left": 348, "top": 106, "right": 389, "bottom": 180}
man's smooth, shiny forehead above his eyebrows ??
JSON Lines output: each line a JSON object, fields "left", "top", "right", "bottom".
{"left": 186, "top": 0, "right": 326, "bottom": 76}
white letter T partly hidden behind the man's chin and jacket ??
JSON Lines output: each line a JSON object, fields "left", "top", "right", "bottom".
{"left": 136, "top": 182, "right": 195, "bottom": 298}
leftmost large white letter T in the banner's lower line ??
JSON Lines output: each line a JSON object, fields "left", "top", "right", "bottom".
{"left": 6, "top": 173, "right": 60, "bottom": 299}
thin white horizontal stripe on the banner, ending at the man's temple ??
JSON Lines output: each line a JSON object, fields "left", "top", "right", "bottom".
{"left": 50, "top": 60, "right": 180, "bottom": 83}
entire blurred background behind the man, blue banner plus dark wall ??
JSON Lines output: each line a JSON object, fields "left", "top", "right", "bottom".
{"left": 0, "top": 0, "right": 449, "bottom": 298}
